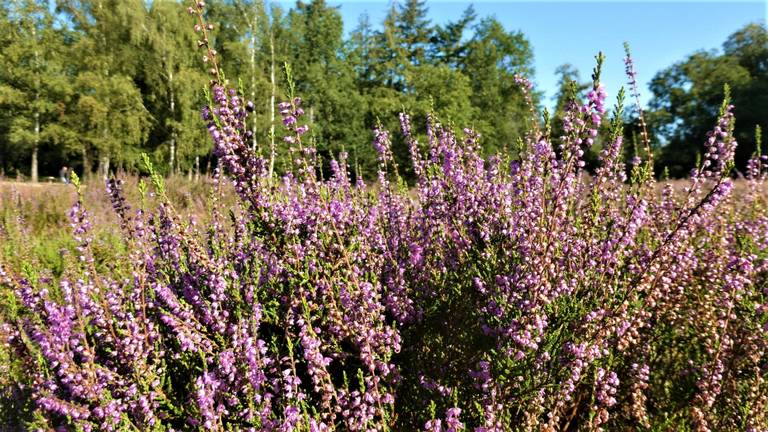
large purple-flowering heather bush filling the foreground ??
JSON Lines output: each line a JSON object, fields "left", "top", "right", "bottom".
{"left": 0, "top": 1, "right": 768, "bottom": 432}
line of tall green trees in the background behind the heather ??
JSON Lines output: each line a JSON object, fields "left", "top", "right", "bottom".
{"left": 0, "top": 0, "right": 768, "bottom": 181}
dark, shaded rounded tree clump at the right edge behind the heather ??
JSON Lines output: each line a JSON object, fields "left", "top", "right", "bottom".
{"left": 649, "top": 24, "right": 768, "bottom": 177}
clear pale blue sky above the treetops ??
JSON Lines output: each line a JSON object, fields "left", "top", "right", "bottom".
{"left": 272, "top": 0, "right": 768, "bottom": 105}
